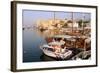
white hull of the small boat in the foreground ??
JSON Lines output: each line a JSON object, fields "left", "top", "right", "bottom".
{"left": 41, "top": 45, "right": 72, "bottom": 59}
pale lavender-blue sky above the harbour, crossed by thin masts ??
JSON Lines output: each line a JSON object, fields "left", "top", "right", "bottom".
{"left": 22, "top": 10, "right": 91, "bottom": 27}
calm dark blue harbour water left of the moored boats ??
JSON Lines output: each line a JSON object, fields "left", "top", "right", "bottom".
{"left": 23, "top": 28, "right": 55, "bottom": 62}
